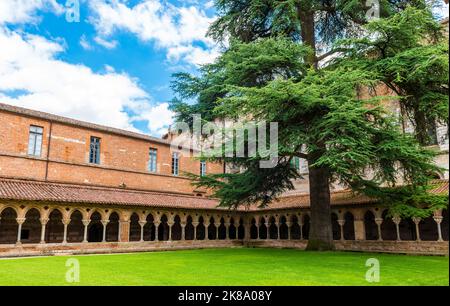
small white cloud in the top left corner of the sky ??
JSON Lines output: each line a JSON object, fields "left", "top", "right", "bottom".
{"left": 0, "top": 0, "right": 64, "bottom": 24}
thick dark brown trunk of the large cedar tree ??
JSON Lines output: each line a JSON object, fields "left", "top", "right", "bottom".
{"left": 306, "top": 155, "right": 334, "bottom": 251}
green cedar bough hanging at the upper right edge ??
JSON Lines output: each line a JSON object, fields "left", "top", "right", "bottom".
{"left": 335, "top": 7, "right": 449, "bottom": 145}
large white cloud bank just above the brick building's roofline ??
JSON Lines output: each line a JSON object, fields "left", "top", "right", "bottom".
{"left": 0, "top": 25, "right": 171, "bottom": 134}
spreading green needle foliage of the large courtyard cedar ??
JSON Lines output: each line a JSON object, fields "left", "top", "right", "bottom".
{"left": 173, "top": 0, "right": 448, "bottom": 215}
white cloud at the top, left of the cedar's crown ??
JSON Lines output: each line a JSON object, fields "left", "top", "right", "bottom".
{"left": 89, "top": 0, "right": 219, "bottom": 65}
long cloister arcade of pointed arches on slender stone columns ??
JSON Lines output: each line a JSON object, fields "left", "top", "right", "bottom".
{"left": 0, "top": 203, "right": 448, "bottom": 252}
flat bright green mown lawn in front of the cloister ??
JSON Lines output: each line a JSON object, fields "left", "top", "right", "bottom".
{"left": 0, "top": 248, "right": 449, "bottom": 286}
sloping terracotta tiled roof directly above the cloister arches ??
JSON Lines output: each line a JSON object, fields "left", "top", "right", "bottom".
{"left": 0, "top": 178, "right": 449, "bottom": 211}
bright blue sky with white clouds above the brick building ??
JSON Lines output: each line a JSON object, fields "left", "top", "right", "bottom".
{"left": 0, "top": 0, "right": 448, "bottom": 136}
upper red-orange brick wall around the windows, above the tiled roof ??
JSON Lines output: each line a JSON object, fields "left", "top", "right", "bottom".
{"left": 0, "top": 112, "right": 223, "bottom": 194}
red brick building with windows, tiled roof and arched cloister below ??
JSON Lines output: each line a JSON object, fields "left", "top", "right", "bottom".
{"left": 0, "top": 104, "right": 448, "bottom": 257}
